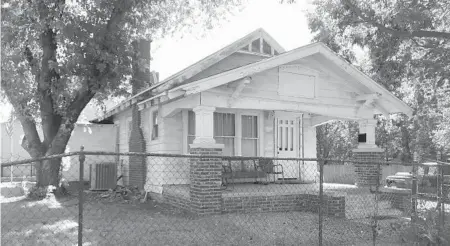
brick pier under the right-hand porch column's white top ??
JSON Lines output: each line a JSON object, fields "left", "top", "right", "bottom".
{"left": 353, "top": 149, "right": 384, "bottom": 187}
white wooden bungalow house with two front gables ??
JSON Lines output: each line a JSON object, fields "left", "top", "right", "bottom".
{"left": 93, "top": 29, "right": 412, "bottom": 192}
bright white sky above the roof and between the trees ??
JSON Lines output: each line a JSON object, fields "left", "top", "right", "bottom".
{"left": 0, "top": 0, "right": 312, "bottom": 122}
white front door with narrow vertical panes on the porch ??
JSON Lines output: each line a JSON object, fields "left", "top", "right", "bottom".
{"left": 275, "top": 112, "right": 300, "bottom": 179}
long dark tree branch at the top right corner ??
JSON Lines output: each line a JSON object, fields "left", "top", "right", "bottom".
{"left": 341, "top": 0, "right": 450, "bottom": 39}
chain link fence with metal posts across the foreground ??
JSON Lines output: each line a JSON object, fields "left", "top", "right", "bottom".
{"left": 1, "top": 149, "right": 450, "bottom": 245}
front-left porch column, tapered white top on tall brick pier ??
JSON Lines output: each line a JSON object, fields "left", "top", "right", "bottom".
{"left": 189, "top": 106, "right": 224, "bottom": 215}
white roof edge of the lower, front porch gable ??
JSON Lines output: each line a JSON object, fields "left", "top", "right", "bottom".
{"left": 169, "top": 42, "right": 412, "bottom": 116}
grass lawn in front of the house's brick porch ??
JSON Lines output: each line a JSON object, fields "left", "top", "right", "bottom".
{"left": 1, "top": 182, "right": 440, "bottom": 245}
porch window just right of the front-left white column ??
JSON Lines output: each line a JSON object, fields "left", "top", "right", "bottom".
{"left": 214, "top": 112, "right": 236, "bottom": 156}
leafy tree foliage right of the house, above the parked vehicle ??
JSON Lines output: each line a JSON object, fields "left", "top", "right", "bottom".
{"left": 307, "top": 0, "right": 450, "bottom": 160}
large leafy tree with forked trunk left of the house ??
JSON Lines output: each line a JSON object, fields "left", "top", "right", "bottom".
{"left": 1, "top": 0, "right": 244, "bottom": 186}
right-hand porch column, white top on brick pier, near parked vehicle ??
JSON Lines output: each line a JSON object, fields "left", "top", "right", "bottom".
{"left": 353, "top": 119, "right": 384, "bottom": 187}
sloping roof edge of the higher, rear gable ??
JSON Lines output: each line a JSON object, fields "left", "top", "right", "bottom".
{"left": 93, "top": 28, "right": 285, "bottom": 121}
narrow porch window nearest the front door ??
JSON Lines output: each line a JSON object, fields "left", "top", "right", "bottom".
{"left": 241, "top": 115, "right": 258, "bottom": 156}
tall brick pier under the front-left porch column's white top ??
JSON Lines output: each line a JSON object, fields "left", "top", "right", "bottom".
{"left": 189, "top": 146, "right": 222, "bottom": 215}
